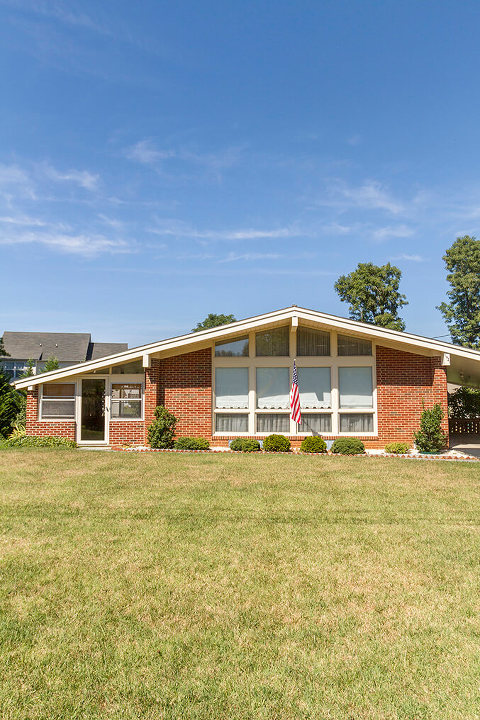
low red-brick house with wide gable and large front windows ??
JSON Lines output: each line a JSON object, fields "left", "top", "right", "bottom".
{"left": 15, "top": 306, "right": 480, "bottom": 448}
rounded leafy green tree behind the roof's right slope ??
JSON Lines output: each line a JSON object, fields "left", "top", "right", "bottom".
{"left": 334, "top": 263, "right": 408, "bottom": 330}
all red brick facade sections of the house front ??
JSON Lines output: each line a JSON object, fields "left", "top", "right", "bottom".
{"left": 23, "top": 346, "right": 448, "bottom": 448}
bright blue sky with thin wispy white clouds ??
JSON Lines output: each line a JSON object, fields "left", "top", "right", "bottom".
{"left": 0, "top": 0, "right": 480, "bottom": 346}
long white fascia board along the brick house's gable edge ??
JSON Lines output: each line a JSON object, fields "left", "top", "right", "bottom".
{"left": 15, "top": 306, "right": 480, "bottom": 389}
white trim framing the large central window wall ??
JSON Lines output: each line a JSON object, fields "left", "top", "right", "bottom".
{"left": 212, "top": 328, "right": 378, "bottom": 438}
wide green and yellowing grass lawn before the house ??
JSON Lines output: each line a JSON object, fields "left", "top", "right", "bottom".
{"left": 0, "top": 450, "right": 480, "bottom": 720}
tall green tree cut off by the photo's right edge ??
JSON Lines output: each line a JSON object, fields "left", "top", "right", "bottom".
{"left": 438, "top": 235, "right": 480, "bottom": 350}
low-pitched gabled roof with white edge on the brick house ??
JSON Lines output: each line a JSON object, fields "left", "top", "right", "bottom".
{"left": 15, "top": 305, "right": 480, "bottom": 388}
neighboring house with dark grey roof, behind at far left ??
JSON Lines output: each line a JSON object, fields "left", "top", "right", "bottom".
{"left": 0, "top": 331, "right": 128, "bottom": 380}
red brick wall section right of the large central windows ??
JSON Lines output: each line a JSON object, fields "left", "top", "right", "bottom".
{"left": 377, "top": 346, "right": 448, "bottom": 447}
